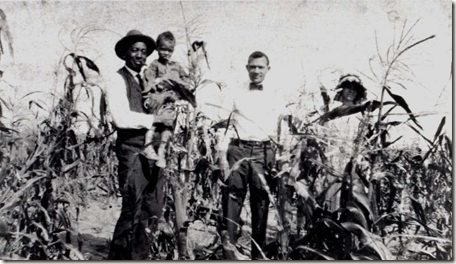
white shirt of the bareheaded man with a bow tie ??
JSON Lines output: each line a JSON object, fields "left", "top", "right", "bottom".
{"left": 227, "top": 79, "right": 290, "bottom": 141}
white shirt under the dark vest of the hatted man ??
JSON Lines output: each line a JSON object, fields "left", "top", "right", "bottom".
{"left": 105, "top": 66, "right": 154, "bottom": 129}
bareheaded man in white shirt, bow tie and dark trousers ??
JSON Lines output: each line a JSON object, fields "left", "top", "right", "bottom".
{"left": 223, "top": 51, "right": 287, "bottom": 259}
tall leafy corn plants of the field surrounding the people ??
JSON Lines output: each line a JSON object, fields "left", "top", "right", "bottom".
{"left": 0, "top": 8, "right": 453, "bottom": 260}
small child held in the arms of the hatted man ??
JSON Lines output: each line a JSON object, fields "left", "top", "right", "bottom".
{"left": 142, "top": 31, "right": 196, "bottom": 168}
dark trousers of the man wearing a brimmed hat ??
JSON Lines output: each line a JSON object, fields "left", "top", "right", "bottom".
{"left": 108, "top": 141, "right": 165, "bottom": 260}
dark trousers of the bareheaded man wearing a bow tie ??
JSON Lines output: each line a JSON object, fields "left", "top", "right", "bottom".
{"left": 222, "top": 141, "right": 275, "bottom": 259}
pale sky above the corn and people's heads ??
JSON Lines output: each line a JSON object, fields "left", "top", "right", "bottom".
{"left": 0, "top": 0, "right": 452, "bottom": 144}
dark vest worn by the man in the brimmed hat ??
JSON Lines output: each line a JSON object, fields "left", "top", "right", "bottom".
{"left": 117, "top": 67, "right": 147, "bottom": 147}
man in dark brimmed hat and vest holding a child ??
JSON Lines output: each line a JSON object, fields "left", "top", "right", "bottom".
{"left": 106, "top": 30, "right": 174, "bottom": 260}
